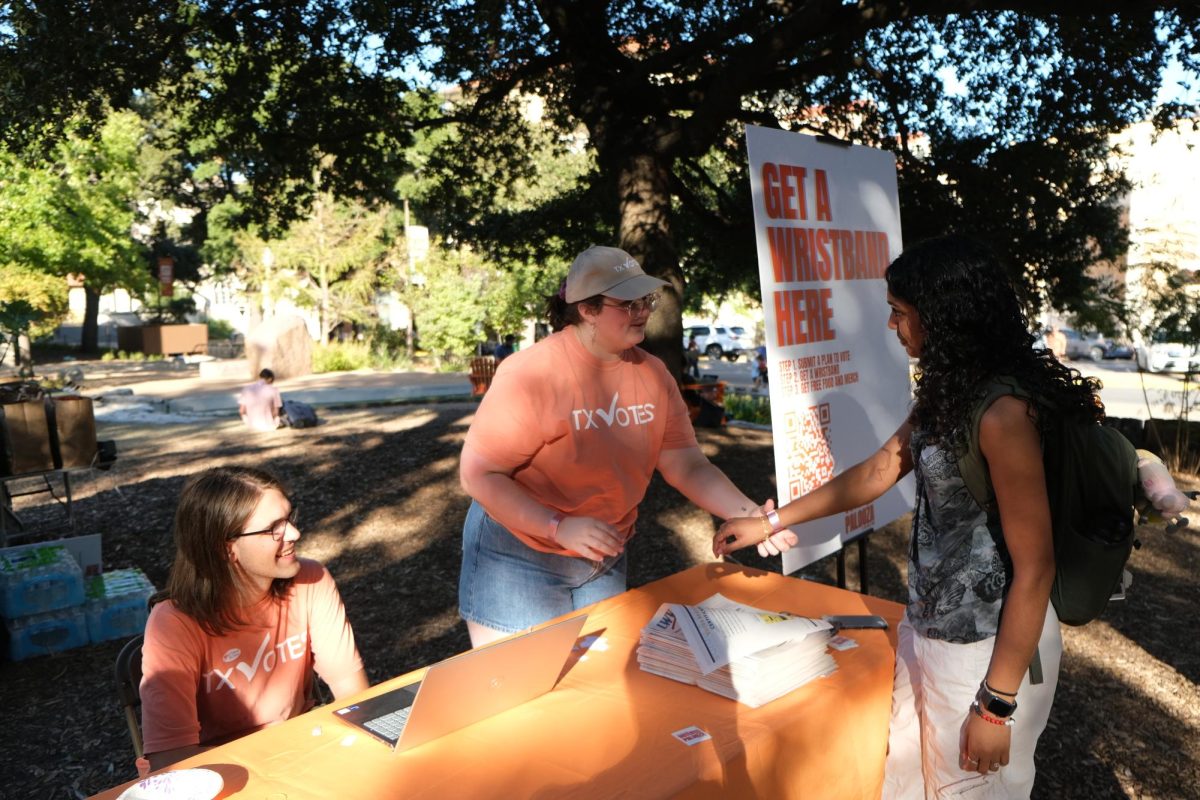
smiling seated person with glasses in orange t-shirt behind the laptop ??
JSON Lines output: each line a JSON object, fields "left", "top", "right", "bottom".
{"left": 139, "top": 467, "right": 367, "bottom": 772}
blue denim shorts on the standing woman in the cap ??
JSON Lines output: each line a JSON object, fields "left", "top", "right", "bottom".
{"left": 458, "top": 501, "right": 625, "bottom": 633}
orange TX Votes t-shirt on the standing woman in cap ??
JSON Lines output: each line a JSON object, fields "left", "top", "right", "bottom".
{"left": 467, "top": 327, "right": 696, "bottom": 555}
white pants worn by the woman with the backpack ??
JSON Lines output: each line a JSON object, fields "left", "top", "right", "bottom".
{"left": 883, "top": 606, "right": 1062, "bottom": 800}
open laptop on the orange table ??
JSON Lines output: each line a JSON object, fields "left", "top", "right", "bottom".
{"left": 335, "top": 614, "right": 587, "bottom": 752}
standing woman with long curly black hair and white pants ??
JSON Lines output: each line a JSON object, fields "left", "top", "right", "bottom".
{"left": 713, "top": 236, "right": 1103, "bottom": 798}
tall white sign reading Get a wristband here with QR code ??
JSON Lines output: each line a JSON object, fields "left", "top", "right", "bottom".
{"left": 746, "top": 126, "right": 913, "bottom": 573}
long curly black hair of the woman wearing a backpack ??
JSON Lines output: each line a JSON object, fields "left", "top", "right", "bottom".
{"left": 886, "top": 235, "right": 1104, "bottom": 447}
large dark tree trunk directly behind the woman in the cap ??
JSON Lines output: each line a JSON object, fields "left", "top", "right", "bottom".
{"left": 617, "top": 154, "right": 683, "bottom": 379}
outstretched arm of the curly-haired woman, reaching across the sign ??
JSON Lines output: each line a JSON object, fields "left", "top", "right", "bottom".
{"left": 713, "top": 421, "right": 912, "bottom": 555}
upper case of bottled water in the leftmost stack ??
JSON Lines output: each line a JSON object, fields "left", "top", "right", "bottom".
{"left": 0, "top": 546, "right": 84, "bottom": 619}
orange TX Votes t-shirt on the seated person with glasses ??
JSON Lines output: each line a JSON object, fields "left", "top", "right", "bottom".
{"left": 142, "top": 559, "right": 362, "bottom": 753}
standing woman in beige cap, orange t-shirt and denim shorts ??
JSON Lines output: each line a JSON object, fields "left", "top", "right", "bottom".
{"left": 458, "top": 247, "right": 758, "bottom": 646}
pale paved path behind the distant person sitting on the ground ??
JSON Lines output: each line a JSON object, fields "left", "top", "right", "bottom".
{"left": 83, "top": 371, "right": 470, "bottom": 419}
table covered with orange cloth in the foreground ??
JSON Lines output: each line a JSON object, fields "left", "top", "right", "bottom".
{"left": 96, "top": 564, "right": 902, "bottom": 800}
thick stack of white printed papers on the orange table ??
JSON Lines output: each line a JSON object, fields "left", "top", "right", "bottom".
{"left": 637, "top": 595, "right": 838, "bottom": 708}
